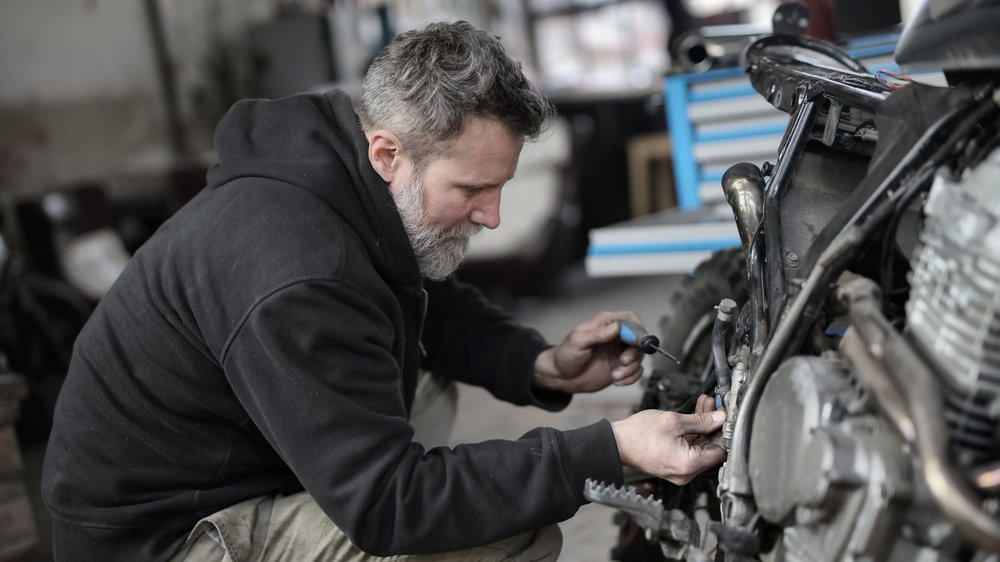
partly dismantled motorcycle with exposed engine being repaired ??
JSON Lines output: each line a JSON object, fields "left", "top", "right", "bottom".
{"left": 585, "top": 0, "right": 1000, "bottom": 562}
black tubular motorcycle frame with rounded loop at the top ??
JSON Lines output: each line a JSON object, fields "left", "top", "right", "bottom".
{"left": 721, "top": 35, "right": 998, "bottom": 544}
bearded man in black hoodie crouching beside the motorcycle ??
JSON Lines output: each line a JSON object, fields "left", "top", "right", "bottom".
{"left": 43, "top": 19, "right": 724, "bottom": 560}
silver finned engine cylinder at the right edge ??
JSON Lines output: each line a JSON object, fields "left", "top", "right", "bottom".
{"left": 907, "top": 145, "right": 1000, "bottom": 465}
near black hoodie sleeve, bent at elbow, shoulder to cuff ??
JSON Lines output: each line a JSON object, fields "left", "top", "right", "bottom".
{"left": 223, "top": 281, "right": 622, "bottom": 556}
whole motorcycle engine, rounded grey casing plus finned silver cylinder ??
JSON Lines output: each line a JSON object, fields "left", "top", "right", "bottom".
{"left": 749, "top": 150, "right": 1000, "bottom": 562}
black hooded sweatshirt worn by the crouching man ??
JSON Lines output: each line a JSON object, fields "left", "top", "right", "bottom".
{"left": 42, "top": 92, "right": 622, "bottom": 560}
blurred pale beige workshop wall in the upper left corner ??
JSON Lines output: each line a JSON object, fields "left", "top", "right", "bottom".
{"left": 0, "top": 0, "right": 273, "bottom": 198}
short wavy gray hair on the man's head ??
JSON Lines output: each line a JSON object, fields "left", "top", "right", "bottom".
{"left": 357, "top": 21, "right": 553, "bottom": 166}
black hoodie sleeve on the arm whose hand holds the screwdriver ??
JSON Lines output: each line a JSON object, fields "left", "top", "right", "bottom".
{"left": 423, "top": 278, "right": 571, "bottom": 411}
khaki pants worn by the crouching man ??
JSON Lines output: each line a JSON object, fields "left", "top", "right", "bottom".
{"left": 171, "top": 375, "right": 562, "bottom": 562}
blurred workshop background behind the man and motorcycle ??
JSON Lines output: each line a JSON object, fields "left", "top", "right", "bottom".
{"left": 0, "top": 0, "right": 913, "bottom": 560}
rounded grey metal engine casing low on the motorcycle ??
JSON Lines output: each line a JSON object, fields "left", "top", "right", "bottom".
{"left": 750, "top": 354, "right": 916, "bottom": 562}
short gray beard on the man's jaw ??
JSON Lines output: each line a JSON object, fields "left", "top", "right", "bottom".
{"left": 389, "top": 177, "right": 483, "bottom": 281}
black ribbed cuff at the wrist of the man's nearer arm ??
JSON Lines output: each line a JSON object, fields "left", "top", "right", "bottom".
{"left": 557, "top": 420, "right": 624, "bottom": 504}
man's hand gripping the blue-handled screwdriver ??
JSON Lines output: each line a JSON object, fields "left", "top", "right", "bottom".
{"left": 532, "top": 312, "right": 642, "bottom": 393}
